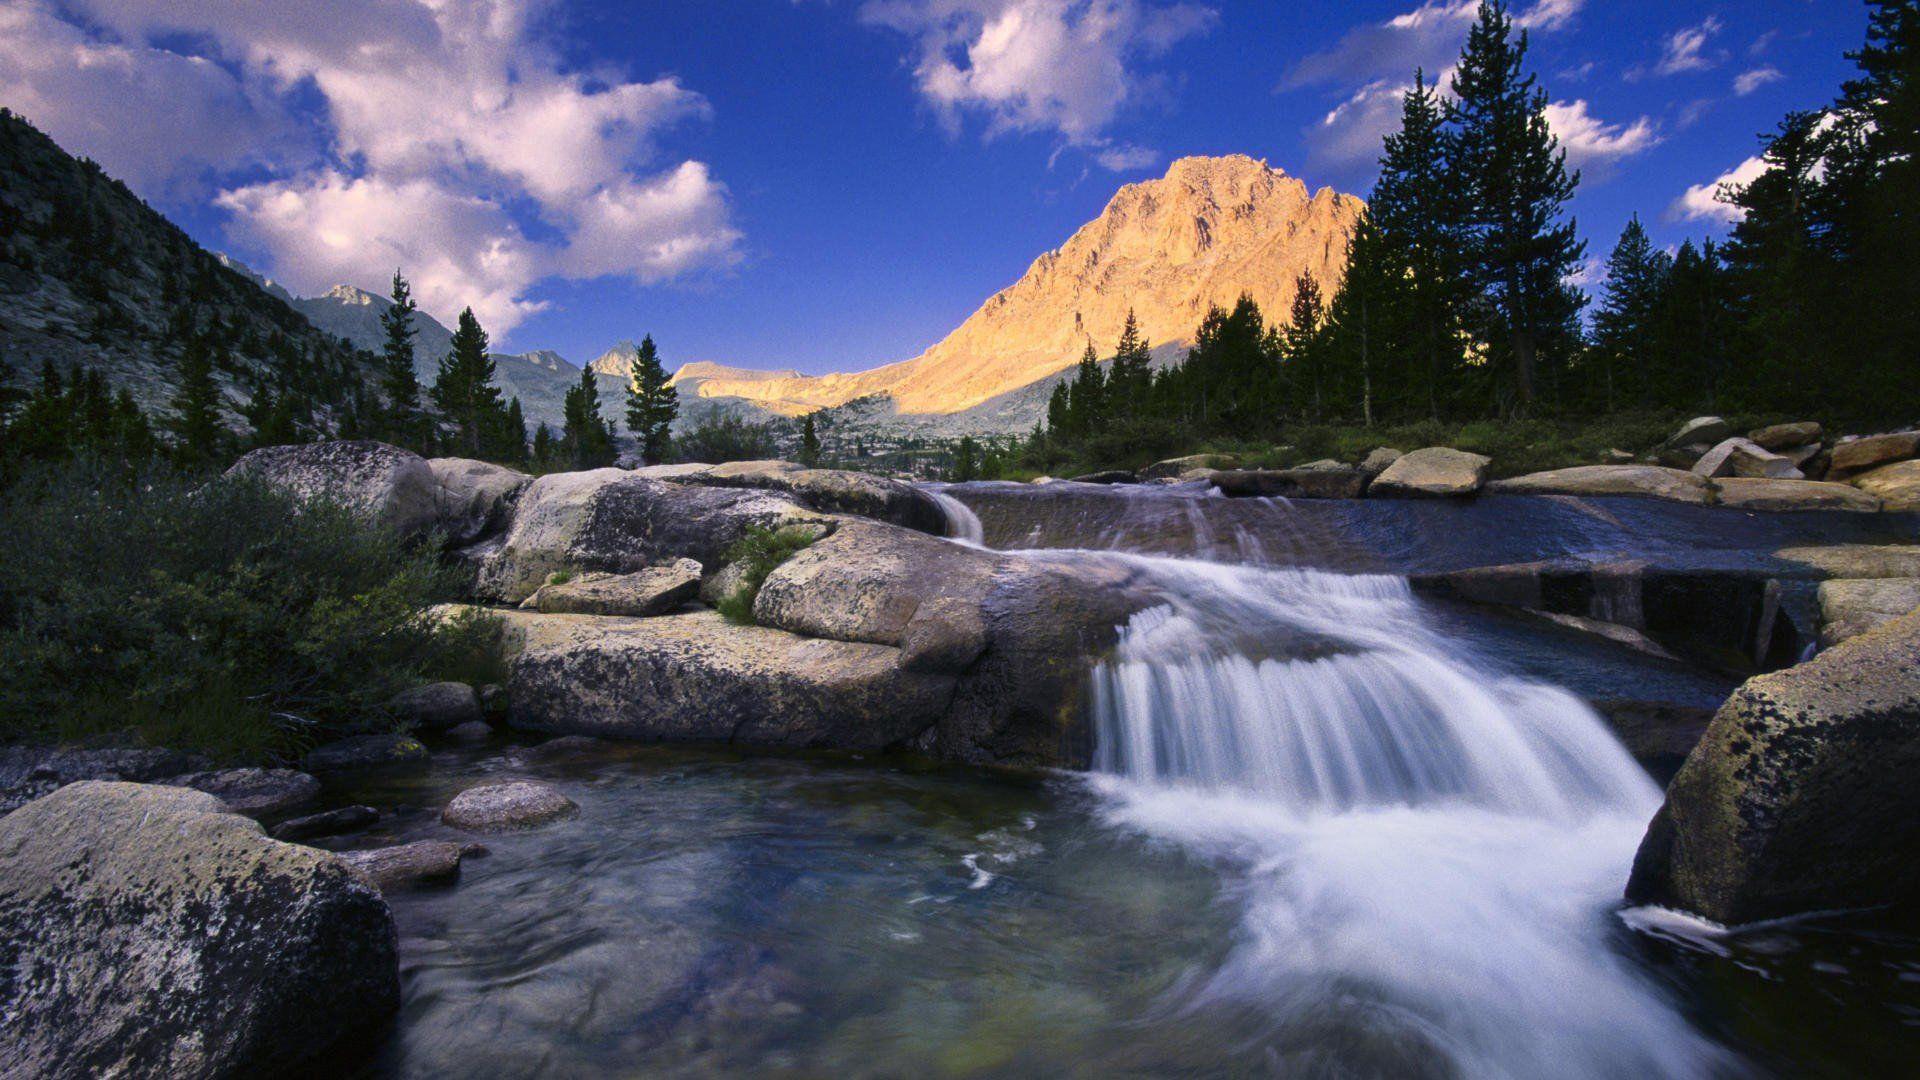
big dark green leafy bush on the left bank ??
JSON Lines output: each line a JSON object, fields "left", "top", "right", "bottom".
{"left": 0, "top": 463, "right": 497, "bottom": 759}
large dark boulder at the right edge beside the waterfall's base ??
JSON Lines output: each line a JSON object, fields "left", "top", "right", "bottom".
{"left": 1626, "top": 613, "right": 1920, "bottom": 924}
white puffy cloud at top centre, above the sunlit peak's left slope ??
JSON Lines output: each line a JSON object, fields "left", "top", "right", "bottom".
{"left": 860, "top": 0, "right": 1217, "bottom": 169}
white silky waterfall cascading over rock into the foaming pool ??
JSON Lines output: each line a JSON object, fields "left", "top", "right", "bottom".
{"left": 1006, "top": 522, "right": 1730, "bottom": 1078}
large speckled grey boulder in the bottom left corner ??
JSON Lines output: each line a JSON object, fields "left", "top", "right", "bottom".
{"left": 0, "top": 782, "right": 399, "bottom": 1078}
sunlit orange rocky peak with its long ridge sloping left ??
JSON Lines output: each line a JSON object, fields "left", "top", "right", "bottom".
{"left": 676, "top": 154, "right": 1365, "bottom": 430}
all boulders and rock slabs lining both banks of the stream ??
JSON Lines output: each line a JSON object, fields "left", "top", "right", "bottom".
{"left": 0, "top": 428, "right": 1920, "bottom": 1076}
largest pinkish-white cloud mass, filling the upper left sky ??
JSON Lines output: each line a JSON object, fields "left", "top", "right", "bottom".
{"left": 0, "top": 0, "right": 739, "bottom": 334}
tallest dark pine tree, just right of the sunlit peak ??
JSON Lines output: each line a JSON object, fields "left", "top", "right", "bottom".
{"left": 1446, "top": 0, "right": 1586, "bottom": 413}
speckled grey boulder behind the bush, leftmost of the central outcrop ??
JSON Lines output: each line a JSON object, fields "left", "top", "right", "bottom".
{"left": 227, "top": 440, "right": 442, "bottom": 532}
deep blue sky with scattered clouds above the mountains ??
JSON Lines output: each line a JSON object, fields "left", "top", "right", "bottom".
{"left": 0, "top": 0, "right": 1864, "bottom": 371}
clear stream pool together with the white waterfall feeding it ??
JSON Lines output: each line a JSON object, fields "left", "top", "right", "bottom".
{"left": 353, "top": 490, "right": 1920, "bottom": 1076}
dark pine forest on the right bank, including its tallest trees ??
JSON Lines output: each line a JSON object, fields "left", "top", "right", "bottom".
{"left": 1006, "top": 0, "right": 1920, "bottom": 477}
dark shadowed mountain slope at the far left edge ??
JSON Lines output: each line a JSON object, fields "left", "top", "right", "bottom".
{"left": 0, "top": 110, "right": 374, "bottom": 423}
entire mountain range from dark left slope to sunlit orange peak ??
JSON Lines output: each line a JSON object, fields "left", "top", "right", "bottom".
{"left": 0, "top": 113, "right": 1365, "bottom": 438}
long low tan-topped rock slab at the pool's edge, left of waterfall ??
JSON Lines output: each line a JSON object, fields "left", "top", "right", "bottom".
{"left": 503, "top": 611, "right": 952, "bottom": 749}
